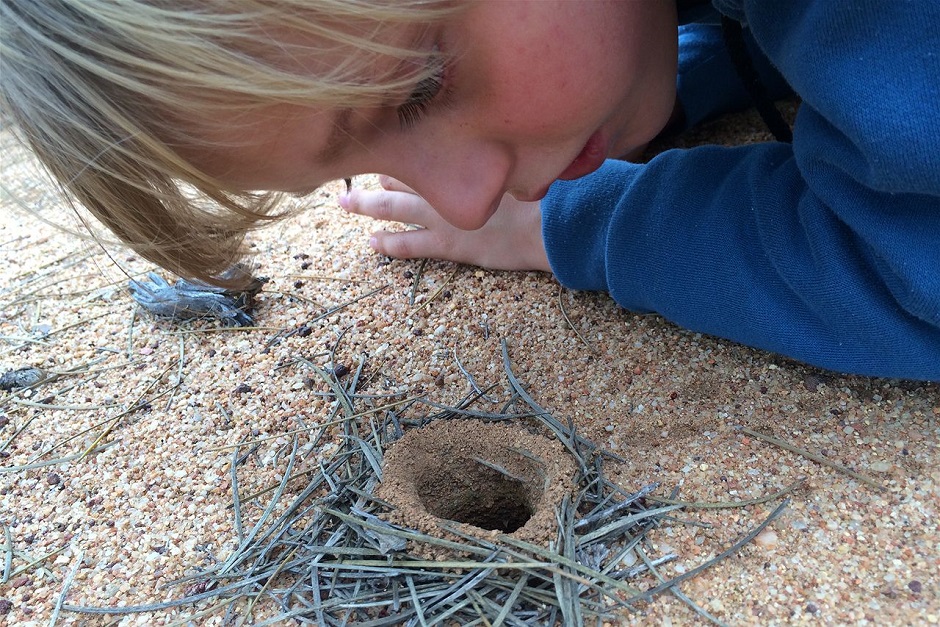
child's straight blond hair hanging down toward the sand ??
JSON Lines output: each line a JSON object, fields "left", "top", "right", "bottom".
{"left": 0, "top": 0, "right": 454, "bottom": 282}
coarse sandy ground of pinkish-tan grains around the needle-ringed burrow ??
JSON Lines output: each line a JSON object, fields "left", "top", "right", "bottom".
{"left": 0, "top": 108, "right": 940, "bottom": 625}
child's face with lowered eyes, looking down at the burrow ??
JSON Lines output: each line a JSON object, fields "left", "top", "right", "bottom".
{"left": 194, "top": 0, "right": 677, "bottom": 229}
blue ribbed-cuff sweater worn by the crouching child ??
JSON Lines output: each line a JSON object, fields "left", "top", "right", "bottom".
{"left": 542, "top": 0, "right": 940, "bottom": 380}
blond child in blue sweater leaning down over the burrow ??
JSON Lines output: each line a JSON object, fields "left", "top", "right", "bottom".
{"left": 0, "top": 0, "right": 940, "bottom": 379}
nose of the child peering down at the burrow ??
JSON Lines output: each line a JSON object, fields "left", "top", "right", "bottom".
{"left": 396, "top": 139, "right": 513, "bottom": 231}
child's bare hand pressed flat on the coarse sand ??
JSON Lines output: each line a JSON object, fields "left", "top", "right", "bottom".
{"left": 340, "top": 176, "right": 551, "bottom": 272}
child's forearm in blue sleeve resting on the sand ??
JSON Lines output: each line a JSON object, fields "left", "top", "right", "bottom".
{"left": 543, "top": 144, "right": 940, "bottom": 379}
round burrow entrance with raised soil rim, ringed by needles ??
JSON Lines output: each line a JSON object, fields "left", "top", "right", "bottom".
{"left": 377, "top": 419, "right": 575, "bottom": 542}
